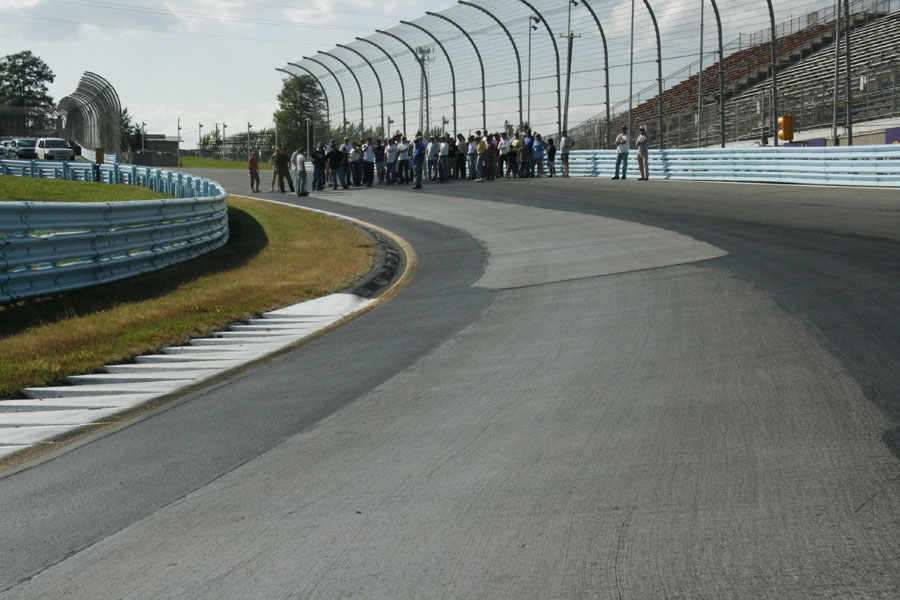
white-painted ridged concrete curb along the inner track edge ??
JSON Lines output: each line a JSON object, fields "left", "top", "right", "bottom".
{"left": 0, "top": 294, "right": 372, "bottom": 458}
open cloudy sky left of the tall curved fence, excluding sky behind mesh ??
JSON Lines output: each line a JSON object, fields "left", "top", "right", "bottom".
{"left": 0, "top": 0, "right": 455, "bottom": 148}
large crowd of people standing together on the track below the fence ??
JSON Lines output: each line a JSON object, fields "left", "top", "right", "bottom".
{"left": 249, "top": 129, "right": 575, "bottom": 196}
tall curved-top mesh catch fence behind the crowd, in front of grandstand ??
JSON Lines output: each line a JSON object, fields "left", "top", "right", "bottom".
{"left": 285, "top": 0, "right": 900, "bottom": 148}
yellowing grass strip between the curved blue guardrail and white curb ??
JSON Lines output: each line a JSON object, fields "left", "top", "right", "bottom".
{"left": 0, "top": 197, "right": 375, "bottom": 398}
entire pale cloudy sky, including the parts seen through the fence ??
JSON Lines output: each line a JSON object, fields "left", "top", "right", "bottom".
{"left": 0, "top": 0, "right": 844, "bottom": 148}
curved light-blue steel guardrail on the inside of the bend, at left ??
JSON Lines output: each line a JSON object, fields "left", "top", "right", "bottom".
{"left": 0, "top": 160, "right": 228, "bottom": 303}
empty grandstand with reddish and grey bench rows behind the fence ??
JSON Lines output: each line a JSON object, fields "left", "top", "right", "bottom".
{"left": 571, "top": 2, "right": 900, "bottom": 148}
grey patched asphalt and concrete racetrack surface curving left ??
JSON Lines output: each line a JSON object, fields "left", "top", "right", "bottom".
{"left": 0, "top": 172, "right": 900, "bottom": 600}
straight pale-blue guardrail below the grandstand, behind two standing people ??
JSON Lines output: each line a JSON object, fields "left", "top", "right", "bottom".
{"left": 557, "top": 145, "right": 900, "bottom": 187}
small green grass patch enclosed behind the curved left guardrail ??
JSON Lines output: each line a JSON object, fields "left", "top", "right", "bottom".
{"left": 0, "top": 175, "right": 168, "bottom": 202}
